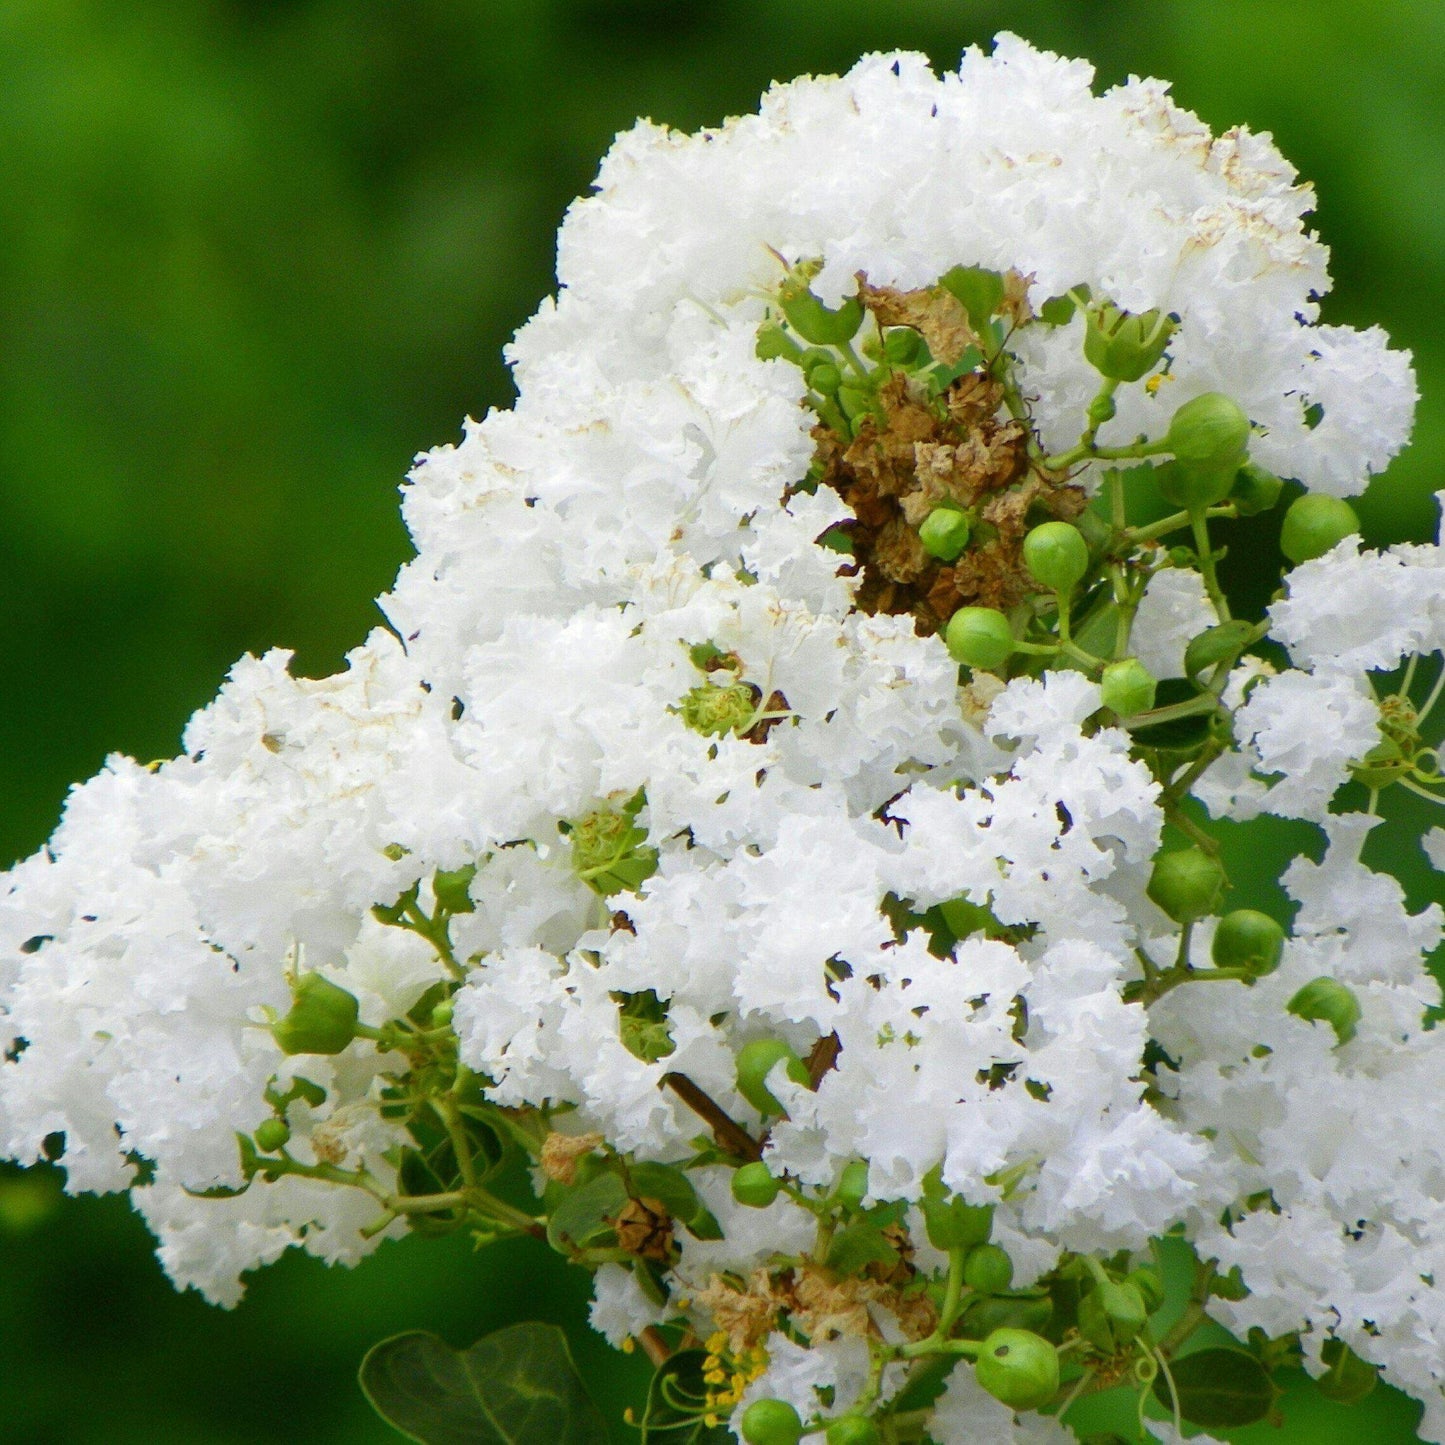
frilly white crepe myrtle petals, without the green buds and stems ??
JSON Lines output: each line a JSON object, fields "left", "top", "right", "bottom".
{"left": 0, "top": 38, "right": 1445, "bottom": 1445}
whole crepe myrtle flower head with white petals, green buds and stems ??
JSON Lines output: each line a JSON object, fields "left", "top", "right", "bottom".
{"left": 0, "top": 36, "right": 1445, "bottom": 1445}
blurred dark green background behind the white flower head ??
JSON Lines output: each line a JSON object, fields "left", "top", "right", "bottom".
{"left": 0, "top": 0, "right": 1445, "bottom": 1445}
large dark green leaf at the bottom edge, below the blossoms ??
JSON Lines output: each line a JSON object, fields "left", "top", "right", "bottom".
{"left": 360, "top": 1324, "right": 607, "bottom": 1445}
